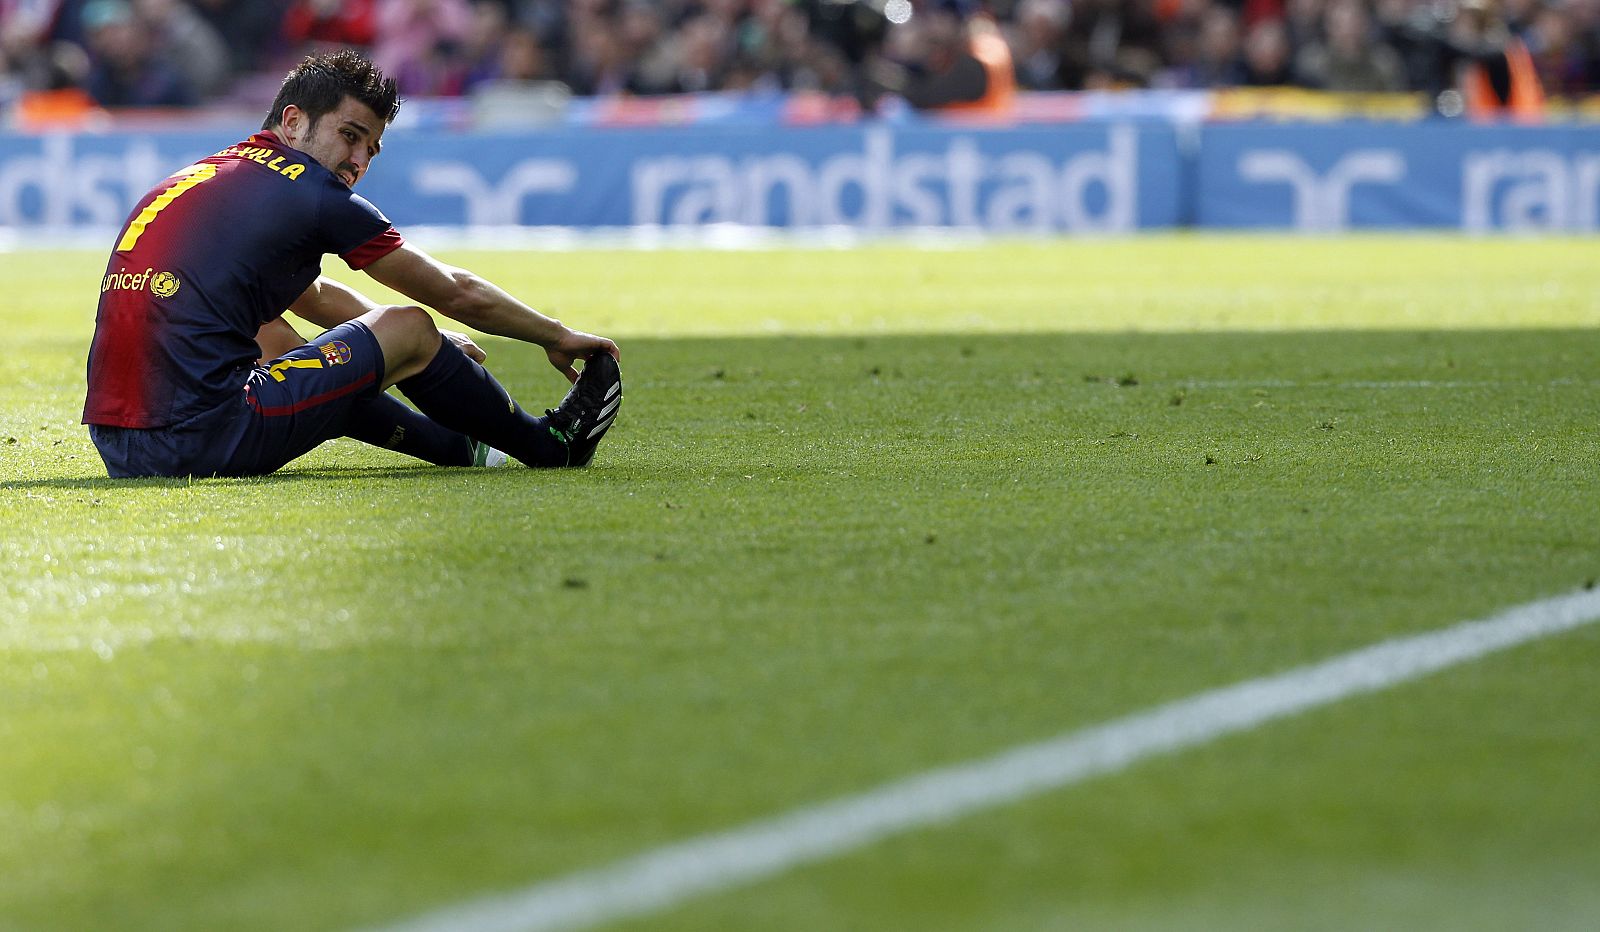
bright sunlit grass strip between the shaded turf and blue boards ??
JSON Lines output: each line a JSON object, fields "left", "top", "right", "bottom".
{"left": 12, "top": 235, "right": 1600, "bottom": 342}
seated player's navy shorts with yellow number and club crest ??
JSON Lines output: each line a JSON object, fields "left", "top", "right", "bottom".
{"left": 90, "top": 320, "right": 384, "bottom": 479}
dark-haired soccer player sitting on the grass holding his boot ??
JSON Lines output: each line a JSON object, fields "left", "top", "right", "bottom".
{"left": 83, "top": 51, "right": 622, "bottom": 477}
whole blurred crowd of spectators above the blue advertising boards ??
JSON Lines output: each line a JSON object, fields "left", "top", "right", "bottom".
{"left": 0, "top": 0, "right": 1600, "bottom": 110}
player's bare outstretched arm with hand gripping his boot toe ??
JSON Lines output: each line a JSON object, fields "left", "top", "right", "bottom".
{"left": 363, "top": 243, "right": 619, "bottom": 381}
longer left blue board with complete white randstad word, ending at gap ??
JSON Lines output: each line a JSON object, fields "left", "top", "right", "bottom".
{"left": 0, "top": 122, "right": 1181, "bottom": 234}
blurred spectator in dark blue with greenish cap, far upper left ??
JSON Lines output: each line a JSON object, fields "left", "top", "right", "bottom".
{"left": 83, "top": 0, "right": 197, "bottom": 107}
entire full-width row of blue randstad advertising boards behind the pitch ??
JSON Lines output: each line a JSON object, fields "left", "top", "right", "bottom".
{"left": 0, "top": 120, "right": 1600, "bottom": 237}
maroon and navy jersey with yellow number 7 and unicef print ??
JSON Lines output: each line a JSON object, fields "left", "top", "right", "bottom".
{"left": 83, "top": 131, "right": 402, "bottom": 428}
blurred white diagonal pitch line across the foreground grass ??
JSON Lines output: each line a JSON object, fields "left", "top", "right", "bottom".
{"left": 371, "top": 591, "right": 1600, "bottom": 932}
